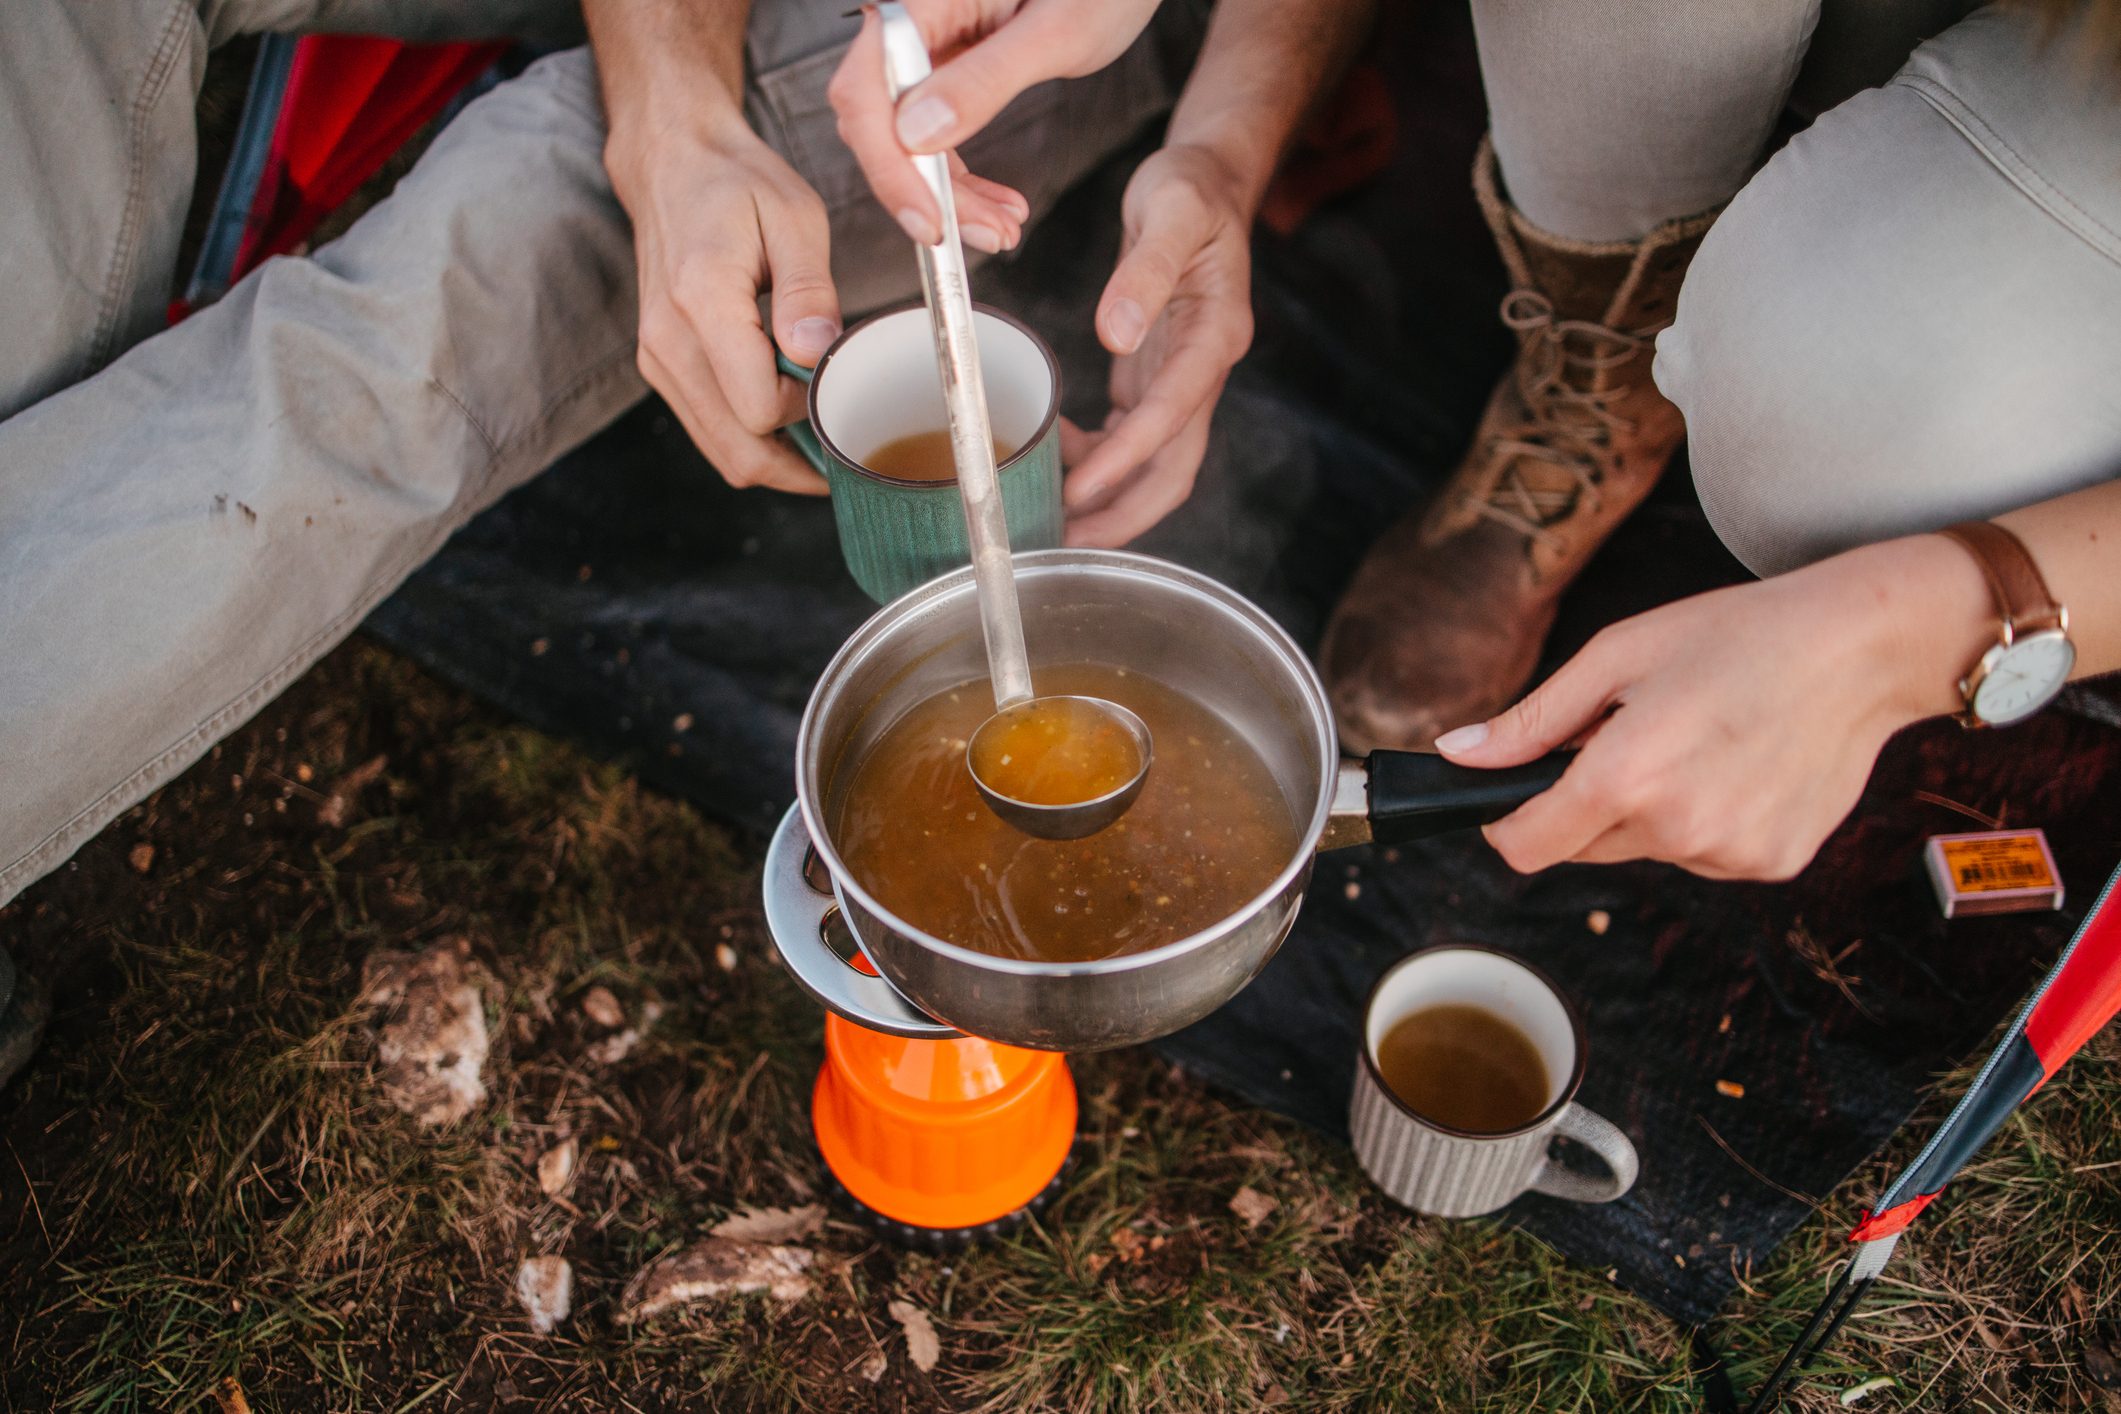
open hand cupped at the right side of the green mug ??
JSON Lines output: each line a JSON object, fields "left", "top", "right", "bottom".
{"left": 1061, "top": 144, "right": 1254, "bottom": 547}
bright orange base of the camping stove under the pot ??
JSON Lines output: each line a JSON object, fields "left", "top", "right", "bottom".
{"left": 810, "top": 1017, "right": 1075, "bottom": 1249}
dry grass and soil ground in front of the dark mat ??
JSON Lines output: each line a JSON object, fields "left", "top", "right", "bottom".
{"left": 0, "top": 642, "right": 2121, "bottom": 1414}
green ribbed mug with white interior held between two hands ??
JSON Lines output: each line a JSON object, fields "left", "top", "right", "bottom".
{"left": 781, "top": 305, "right": 1063, "bottom": 604}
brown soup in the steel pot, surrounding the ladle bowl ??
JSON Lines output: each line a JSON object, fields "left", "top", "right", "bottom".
{"left": 834, "top": 664, "right": 1298, "bottom": 962}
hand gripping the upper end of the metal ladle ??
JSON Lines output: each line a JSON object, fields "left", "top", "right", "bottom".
{"left": 829, "top": 0, "right": 1156, "bottom": 243}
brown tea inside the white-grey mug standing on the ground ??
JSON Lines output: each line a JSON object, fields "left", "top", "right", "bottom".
{"left": 1377, "top": 1003, "right": 1548, "bottom": 1134}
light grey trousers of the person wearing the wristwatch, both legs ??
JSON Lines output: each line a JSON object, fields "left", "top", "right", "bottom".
{"left": 1474, "top": 0, "right": 2121, "bottom": 575}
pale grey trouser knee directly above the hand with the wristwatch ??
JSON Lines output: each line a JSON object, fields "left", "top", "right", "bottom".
{"left": 1654, "top": 66, "right": 2121, "bottom": 575}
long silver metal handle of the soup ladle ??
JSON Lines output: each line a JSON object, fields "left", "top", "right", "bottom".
{"left": 876, "top": 0, "right": 1031, "bottom": 712}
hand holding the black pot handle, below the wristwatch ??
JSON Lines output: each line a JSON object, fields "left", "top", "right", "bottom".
{"left": 1436, "top": 536, "right": 1996, "bottom": 880}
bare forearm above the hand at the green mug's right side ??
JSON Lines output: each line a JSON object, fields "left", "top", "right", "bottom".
{"left": 1164, "top": 0, "right": 1377, "bottom": 210}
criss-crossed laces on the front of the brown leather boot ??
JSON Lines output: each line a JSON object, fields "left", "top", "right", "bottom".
{"left": 1474, "top": 290, "right": 1650, "bottom": 543}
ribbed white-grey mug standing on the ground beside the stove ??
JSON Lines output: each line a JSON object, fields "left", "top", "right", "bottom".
{"left": 1349, "top": 943, "right": 1640, "bottom": 1217}
